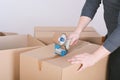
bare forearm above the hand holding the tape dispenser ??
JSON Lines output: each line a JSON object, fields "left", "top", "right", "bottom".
{"left": 74, "top": 16, "right": 91, "bottom": 34}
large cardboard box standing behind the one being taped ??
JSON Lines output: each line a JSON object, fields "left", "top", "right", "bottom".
{"left": 34, "top": 26, "right": 103, "bottom": 45}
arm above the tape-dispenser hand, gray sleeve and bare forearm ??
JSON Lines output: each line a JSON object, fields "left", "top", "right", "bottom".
{"left": 74, "top": 0, "right": 101, "bottom": 34}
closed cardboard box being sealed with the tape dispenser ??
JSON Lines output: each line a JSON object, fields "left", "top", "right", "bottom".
{"left": 20, "top": 42, "right": 107, "bottom": 80}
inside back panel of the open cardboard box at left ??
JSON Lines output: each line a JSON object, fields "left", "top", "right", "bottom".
{"left": 0, "top": 35, "right": 27, "bottom": 50}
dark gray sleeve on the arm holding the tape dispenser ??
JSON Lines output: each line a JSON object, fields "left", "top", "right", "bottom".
{"left": 81, "top": 0, "right": 101, "bottom": 19}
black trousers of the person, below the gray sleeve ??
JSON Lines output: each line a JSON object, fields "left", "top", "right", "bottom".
{"left": 108, "top": 47, "right": 120, "bottom": 80}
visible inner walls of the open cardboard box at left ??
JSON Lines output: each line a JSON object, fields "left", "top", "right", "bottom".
{"left": 0, "top": 35, "right": 44, "bottom": 50}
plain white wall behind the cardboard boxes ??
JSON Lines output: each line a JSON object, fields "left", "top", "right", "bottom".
{"left": 0, "top": 0, "right": 106, "bottom": 35}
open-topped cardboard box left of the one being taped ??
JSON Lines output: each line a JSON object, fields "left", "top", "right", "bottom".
{"left": 0, "top": 35, "right": 45, "bottom": 80}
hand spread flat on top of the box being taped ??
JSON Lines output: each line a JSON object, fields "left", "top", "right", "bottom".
{"left": 68, "top": 53, "right": 97, "bottom": 71}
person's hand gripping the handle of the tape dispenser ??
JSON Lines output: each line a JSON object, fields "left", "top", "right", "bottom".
{"left": 68, "top": 32, "right": 80, "bottom": 45}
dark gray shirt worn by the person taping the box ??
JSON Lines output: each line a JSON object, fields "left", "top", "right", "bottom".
{"left": 81, "top": 0, "right": 120, "bottom": 52}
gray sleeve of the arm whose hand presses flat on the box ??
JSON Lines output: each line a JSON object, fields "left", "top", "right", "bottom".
{"left": 103, "top": 21, "right": 120, "bottom": 52}
